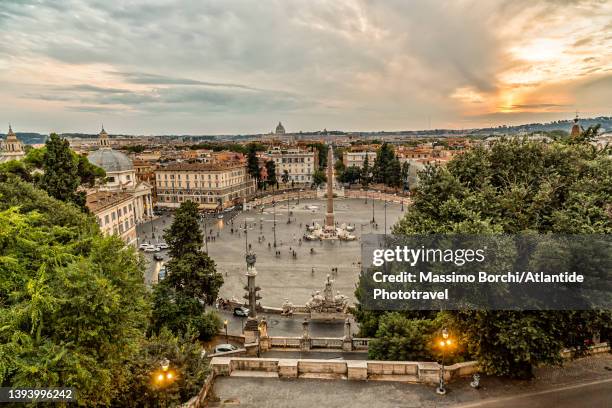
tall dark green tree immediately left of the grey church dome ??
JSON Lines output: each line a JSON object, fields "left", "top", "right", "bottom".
{"left": 40, "top": 133, "right": 85, "bottom": 208}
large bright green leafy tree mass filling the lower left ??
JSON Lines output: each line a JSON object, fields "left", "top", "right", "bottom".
{"left": 0, "top": 178, "right": 149, "bottom": 405}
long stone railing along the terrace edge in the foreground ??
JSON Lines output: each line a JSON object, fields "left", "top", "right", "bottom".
{"left": 211, "top": 357, "right": 478, "bottom": 384}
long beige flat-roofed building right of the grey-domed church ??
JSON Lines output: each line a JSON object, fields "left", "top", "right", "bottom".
{"left": 155, "top": 162, "right": 257, "bottom": 210}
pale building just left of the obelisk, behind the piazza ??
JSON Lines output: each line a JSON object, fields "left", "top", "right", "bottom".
{"left": 265, "top": 146, "right": 319, "bottom": 184}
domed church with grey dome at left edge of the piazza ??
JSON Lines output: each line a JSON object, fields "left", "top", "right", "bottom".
{"left": 87, "top": 128, "right": 153, "bottom": 223}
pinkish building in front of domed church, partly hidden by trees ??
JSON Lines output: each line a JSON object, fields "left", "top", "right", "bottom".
{"left": 86, "top": 191, "right": 136, "bottom": 246}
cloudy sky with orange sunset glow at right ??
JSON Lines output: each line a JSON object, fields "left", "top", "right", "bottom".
{"left": 0, "top": 0, "right": 612, "bottom": 135}
